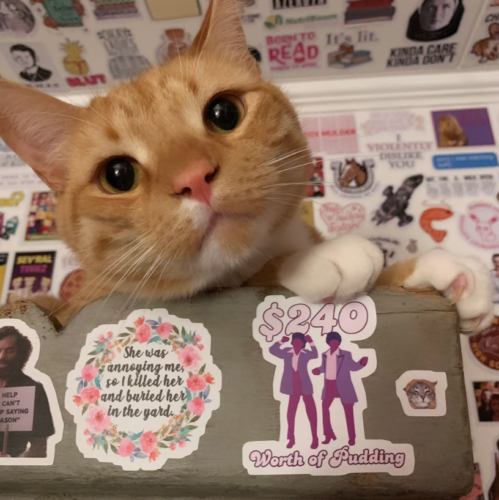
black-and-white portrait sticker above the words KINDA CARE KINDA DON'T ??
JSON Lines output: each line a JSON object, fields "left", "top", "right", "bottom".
{"left": 406, "top": 0, "right": 464, "bottom": 42}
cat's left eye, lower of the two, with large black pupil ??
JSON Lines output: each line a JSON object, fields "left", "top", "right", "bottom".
{"left": 99, "top": 156, "right": 140, "bottom": 194}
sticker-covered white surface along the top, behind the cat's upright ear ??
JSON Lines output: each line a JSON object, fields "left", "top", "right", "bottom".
{"left": 0, "top": 0, "right": 499, "bottom": 93}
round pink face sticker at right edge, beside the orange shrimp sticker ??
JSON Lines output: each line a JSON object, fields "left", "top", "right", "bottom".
{"left": 459, "top": 203, "right": 499, "bottom": 249}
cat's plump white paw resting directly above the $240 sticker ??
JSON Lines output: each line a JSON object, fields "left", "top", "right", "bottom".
{"left": 279, "top": 235, "right": 383, "bottom": 303}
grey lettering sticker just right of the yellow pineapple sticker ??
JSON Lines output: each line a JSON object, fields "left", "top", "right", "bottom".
{"left": 98, "top": 28, "right": 150, "bottom": 80}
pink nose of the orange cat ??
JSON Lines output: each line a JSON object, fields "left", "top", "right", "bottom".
{"left": 173, "top": 160, "right": 216, "bottom": 205}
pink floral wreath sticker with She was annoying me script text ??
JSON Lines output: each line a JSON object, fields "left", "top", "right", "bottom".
{"left": 65, "top": 309, "right": 222, "bottom": 470}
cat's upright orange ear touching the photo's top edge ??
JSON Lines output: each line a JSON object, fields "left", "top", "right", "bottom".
{"left": 190, "top": 0, "right": 260, "bottom": 73}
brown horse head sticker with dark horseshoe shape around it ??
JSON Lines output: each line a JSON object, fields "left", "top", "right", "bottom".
{"left": 331, "top": 158, "right": 376, "bottom": 198}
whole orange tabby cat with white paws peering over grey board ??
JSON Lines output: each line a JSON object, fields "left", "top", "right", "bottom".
{"left": 0, "top": 0, "right": 493, "bottom": 331}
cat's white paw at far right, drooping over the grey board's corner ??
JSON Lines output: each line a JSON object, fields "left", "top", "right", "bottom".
{"left": 404, "top": 249, "right": 494, "bottom": 333}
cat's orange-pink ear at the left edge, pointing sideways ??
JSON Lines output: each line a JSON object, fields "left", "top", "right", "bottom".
{"left": 0, "top": 79, "right": 85, "bottom": 191}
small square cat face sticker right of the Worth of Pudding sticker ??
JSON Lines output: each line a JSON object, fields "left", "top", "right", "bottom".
{"left": 395, "top": 370, "right": 447, "bottom": 417}
